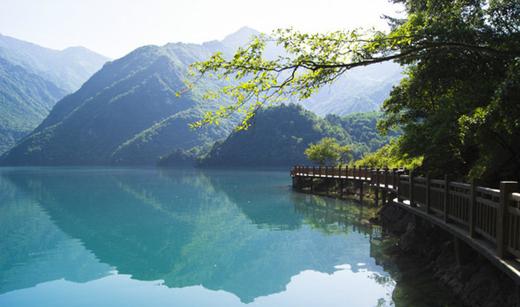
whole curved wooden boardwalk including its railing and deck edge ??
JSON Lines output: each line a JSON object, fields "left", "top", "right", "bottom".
{"left": 291, "top": 166, "right": 520, "bottom": 286}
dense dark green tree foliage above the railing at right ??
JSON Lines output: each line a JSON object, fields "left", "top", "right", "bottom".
{"left": 381, "top": 1, "right": 520, "bottom": 183}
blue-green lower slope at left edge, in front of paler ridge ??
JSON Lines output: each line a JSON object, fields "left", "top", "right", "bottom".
{"left": 0, "top": 58, "right": 65, "bottom": 155}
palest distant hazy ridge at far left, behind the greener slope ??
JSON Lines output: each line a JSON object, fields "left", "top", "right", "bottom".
{"left": 0, "top": 34, "right": 111, "bottom": 93}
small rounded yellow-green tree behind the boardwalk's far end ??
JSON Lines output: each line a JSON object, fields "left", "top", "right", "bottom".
{"left": 304, "top": 138, "right": 352, "bottom": 166}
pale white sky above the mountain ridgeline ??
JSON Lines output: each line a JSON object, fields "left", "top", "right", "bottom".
{"left": 0, "top": 0, "right": 401, "bottom": 59}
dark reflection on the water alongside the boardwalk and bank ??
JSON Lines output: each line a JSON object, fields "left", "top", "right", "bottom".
{"left": 292, "top": 192, "right": 461, "bottom": 307}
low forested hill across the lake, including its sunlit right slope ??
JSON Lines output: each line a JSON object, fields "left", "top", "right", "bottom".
{"left": 191, "top": 104, "right": 391, "bottom": 167}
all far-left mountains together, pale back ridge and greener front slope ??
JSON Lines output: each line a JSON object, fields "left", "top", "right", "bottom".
{"left": 0, "top": 34, "right": 108, "bottom": 154}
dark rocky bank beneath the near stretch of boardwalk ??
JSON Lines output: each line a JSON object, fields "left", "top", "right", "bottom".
{"left": 372, "top": 204, "right": 519, "bottom": 307}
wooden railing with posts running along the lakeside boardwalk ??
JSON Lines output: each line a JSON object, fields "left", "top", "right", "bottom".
{"left": 291, "top": 166, "right": 520, "bottom": 259}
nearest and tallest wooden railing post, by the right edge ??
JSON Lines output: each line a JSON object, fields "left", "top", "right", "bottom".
{"left": 496, "top": 181, "right": 518, "bottom": 259}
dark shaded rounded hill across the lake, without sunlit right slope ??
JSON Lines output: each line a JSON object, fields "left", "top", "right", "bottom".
{"left": 198, "top": 104, "right": 338, "bottom": 167}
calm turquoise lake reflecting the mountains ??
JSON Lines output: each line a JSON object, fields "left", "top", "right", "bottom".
{"left": 0, "top": 167, "right": 457, "bottom": 307}
